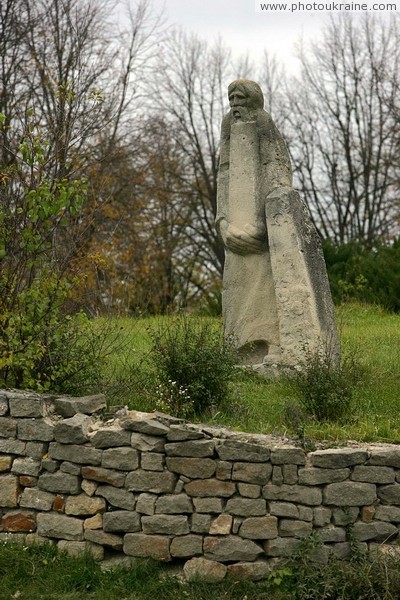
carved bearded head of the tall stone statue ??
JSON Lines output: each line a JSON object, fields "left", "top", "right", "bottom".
{"left": 228, "top": 79, "right": 264, "bottom": 121}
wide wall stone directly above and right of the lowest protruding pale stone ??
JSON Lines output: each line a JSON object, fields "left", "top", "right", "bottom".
{"left": 203, "top": 535, "right": 263, "bottom": 562}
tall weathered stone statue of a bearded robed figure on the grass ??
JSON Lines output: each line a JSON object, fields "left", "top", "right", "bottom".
{"left": 216, "top": 80, "right": 339, "bottom": 366}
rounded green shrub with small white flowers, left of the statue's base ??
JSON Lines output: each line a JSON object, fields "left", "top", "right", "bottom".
{"left": 150, "top": 316, "right": 235, "bottom": 417}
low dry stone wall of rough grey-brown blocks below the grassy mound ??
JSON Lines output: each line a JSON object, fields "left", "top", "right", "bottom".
{"left": 0, "top": 391, "right": 400, "bottom": 580}
